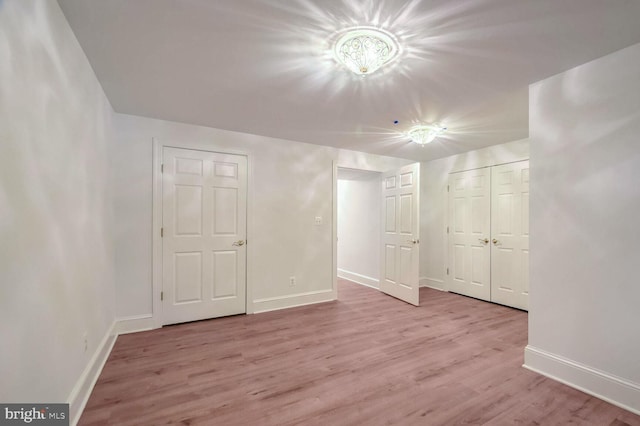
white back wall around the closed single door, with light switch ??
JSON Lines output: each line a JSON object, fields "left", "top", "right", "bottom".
{"left": 115, "top": 115, "right": 408, "bottom": 318}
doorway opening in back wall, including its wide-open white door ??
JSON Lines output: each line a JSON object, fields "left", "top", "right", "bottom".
{"left": 333, "top": 163, "right": 420, "bottom": 306}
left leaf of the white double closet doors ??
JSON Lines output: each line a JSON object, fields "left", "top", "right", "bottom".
{"left": 448, "top": 168, "right": 491, "bottom": 300}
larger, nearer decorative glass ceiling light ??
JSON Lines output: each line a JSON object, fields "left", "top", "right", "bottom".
{"left": 334, "top": 27, "right": 398, "bottom": 77}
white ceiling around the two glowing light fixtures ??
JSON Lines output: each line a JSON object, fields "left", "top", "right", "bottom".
{"left": 59, "top": 0, "right": 640, "bottom": 161}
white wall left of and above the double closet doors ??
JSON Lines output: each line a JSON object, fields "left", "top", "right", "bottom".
{"left": 420, "top": 139, "right": 529, "bottom": 290}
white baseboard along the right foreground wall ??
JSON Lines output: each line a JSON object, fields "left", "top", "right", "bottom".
{"left": 523, "top": 346, "right": 640, "bottom": 415}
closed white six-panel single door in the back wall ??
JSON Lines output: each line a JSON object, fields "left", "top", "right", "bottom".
{"left": 162, "top": 147, "right": 247, "bottom": 324}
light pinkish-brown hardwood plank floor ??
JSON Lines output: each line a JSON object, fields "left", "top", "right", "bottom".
{"left": 80, "top": 280, "right": 640, "bottom": 426}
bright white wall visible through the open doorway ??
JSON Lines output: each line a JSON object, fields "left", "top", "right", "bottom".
{"left": 338, "top": 171, "right": 381, "bottom": 288}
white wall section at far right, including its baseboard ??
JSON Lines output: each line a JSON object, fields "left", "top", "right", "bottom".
{"left": 526, "top": 44, "right": 640, "bottom": 412}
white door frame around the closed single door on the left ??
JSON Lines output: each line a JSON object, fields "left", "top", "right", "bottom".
{"left": 150, "top": 138, "right": 254, "bottom": 328}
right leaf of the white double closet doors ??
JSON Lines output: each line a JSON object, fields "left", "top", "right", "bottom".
{"left": 491, "top": 161, "right": 529, "bottom": 310}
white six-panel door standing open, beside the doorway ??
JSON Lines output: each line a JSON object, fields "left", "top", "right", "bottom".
{"left": 380, "top": 163, "right": 420, "bottom": 306}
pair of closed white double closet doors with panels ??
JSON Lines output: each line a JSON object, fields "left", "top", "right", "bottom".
{"left": 447, "top": 160, "right": 529, "bottom": 310}
